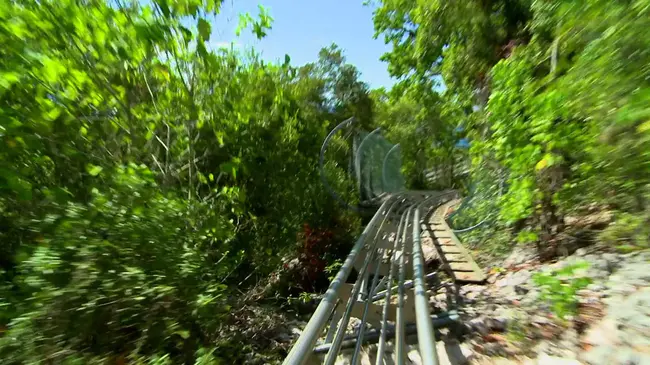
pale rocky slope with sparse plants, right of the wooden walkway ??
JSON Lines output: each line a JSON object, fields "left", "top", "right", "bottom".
{"left": 430, "top": 247, "right": 650, "bottom": 365}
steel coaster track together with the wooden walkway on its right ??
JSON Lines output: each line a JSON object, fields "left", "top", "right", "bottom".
{"left": 284, "top": 191, "right": 485, "bottom": 365}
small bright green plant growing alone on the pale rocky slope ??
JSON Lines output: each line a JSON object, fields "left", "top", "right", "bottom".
{"left": 533, "top": 261, "right": 591, "bottom": 318}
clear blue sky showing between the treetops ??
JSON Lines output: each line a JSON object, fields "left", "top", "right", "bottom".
{"left": 210, "top": 0, "right": 395, "bottom": 88}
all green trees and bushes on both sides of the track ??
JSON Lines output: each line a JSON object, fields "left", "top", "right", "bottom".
{"left": 0, "top": 0, "right": 650, "bottom": 364}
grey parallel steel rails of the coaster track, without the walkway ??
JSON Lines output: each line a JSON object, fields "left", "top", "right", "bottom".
{"left": 284, "top": 191, "right": 457, "bottom": 365}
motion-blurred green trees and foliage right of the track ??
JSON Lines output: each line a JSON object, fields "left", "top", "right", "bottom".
{"left": 374, "top": 0, "right": 650, "bottom": 242}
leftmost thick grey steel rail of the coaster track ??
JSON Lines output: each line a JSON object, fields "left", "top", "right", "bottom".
{"left": 283, "top": 199, "right": 391, "bottom": 365}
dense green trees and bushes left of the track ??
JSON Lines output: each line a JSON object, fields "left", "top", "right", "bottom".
{"left": 0, "top": 0, "right": 364, "bottom": 364}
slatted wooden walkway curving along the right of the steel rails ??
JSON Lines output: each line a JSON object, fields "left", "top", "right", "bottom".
{"left": 422, "top": 200, "right": 486, "bottom": 283}
